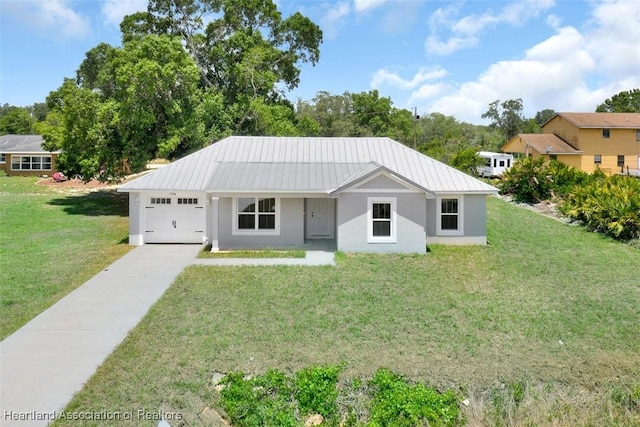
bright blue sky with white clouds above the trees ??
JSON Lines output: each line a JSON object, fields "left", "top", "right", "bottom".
{"left": 0, "top": 0, "right": 640, "bottom": 124}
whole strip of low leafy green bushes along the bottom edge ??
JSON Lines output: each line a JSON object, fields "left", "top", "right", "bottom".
{"left": 221, "top": 365, "right": 462, "bottom": 427}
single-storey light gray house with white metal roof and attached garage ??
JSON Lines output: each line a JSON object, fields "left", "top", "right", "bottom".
{"left": 118, "top": 136, "right": 497, "bottom": 253}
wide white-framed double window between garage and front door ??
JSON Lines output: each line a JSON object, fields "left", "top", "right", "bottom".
{"left": 234, "top": 197, "right": 280, "bottom": 234}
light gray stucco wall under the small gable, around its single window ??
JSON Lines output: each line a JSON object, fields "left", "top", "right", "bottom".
{"left": 336, "top": 192, "right": 426, "bottom": 253}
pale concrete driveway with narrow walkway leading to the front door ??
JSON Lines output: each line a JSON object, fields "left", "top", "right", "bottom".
{"left": 0, "top": 245, "right": 335, "bottom": 427}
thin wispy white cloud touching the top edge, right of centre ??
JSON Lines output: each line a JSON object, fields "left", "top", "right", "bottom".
{"left": 425, "top": 0, "right": 554, "bottom": 55}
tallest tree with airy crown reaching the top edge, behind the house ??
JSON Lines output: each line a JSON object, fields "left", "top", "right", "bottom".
{"left": 127, "top": 0, "right": 322, "bottom": 134}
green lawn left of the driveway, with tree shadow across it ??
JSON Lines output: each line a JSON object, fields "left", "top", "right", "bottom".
{"left": 0, "top": 176, "right": 130, "bottom": 339}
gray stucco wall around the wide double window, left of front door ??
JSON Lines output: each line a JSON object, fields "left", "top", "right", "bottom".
{"left": 218, "top": 197, "right": 304, "bottom": 249}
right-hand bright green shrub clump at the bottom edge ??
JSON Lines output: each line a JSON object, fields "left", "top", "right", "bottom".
{"left": 370, "top": 369, "right": 459, "bottom": 427}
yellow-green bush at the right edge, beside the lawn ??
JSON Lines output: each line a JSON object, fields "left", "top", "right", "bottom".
{"left": 560, "top": 175, "right": 640, "bottom": 240}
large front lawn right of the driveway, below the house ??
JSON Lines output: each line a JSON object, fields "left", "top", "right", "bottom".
{"left": 56, "top": 198, "right": 640, "bottom": 426}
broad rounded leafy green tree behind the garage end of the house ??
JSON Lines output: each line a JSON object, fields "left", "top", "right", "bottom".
{"left": 43, "top": 35, "right": 209, "bottom": 180}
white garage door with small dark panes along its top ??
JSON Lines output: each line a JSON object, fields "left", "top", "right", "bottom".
{"left": 144, "top": 196, "right": 205, "bottom": 243}
